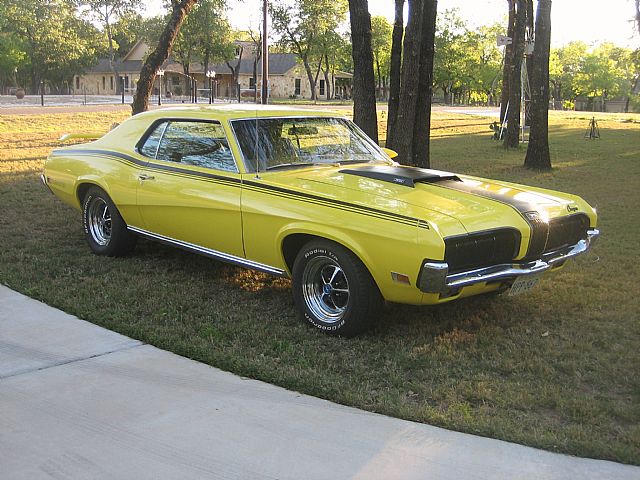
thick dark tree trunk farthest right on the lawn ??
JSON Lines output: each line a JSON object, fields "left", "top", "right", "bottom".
{"left": 524, "top": 0, "right": 551, "bottom": 170}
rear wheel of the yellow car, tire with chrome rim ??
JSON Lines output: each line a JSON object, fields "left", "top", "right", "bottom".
{"left": 82, "top": 187, "right": 138, "bottom": 257}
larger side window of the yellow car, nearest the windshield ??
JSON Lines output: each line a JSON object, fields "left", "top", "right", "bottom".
{"left": 154, "top": 121, "right": 238, "bottom": 172}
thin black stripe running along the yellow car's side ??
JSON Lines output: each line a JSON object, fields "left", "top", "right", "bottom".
{"left": 51, "top": 149, "right": 429, "bottom": 230}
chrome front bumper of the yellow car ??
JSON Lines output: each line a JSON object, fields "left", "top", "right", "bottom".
{"left": 418, "top": 228, "right": 600, "bottom": 295}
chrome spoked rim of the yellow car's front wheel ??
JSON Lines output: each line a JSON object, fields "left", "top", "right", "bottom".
{"left": 302, "top": 256, "right": 349, "bottom": 324}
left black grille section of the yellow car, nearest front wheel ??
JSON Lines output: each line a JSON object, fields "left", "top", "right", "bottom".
{"left": 444, "top": 228, "right": 520, "bottom": 273}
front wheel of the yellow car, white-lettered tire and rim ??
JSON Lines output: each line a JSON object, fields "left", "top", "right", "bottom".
{"left": 292, "top": 240, "right": 382, "bottom": 337}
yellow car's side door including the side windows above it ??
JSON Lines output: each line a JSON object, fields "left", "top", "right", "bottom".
{"left": 137, "top": 119, "right": 244, "bottom": 257}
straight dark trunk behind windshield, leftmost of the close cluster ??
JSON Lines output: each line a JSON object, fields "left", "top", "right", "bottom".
{"left": 349, "top": 0, "right": 378, "bottom": 143}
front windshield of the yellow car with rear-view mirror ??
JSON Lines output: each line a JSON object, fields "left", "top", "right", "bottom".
{"left": 232, "top": 117, "right": 389, "bottom": 172}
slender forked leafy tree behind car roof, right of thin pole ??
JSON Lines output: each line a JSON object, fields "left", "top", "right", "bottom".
{"left": 269, "top": 0, "right": 347, "bottom": 100}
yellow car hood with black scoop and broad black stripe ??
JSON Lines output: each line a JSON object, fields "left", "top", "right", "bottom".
{"left": 264, "top": 165, "right": 578, "bottom": 236}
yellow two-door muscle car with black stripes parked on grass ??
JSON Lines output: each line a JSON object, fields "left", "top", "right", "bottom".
{"left": 42, "top": 105, "right": 599, "bottom": 336}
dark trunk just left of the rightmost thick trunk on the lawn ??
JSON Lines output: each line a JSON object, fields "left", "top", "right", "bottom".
{"left": 504, "top": 0, "right": 527, "bottom": 148}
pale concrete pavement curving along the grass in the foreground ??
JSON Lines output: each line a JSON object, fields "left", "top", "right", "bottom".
{"left": 0, "top": 285, "right": 640, "bottom": 480}
